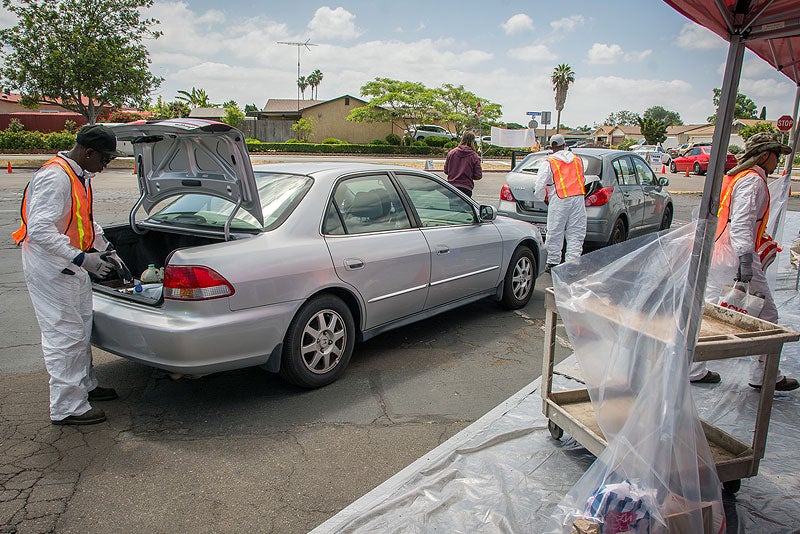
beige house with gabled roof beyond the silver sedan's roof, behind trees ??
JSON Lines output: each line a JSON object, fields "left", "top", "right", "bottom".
{"left": 246, "top": 95, "right": 403, "bottom": 144}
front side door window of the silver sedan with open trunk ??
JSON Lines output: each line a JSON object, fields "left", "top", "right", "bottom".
{"left": 397, "top": 174, "right": 478, "bottom": 227}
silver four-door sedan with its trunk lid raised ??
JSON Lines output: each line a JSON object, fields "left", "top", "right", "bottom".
{"left": 92, "top": 119, "right": 542, "bottom": 388}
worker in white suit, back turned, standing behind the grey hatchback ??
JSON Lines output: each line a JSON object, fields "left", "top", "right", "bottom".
{"left": 533, "top": 134, "right": 586, "bottom": 273}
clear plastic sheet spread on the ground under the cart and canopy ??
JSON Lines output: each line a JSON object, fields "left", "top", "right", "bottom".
{"left": 314, "top": 212, "right": 800, "bottom": 534}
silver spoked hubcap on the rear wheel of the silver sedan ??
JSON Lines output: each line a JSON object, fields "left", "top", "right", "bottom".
{"left": 300, "top": 310, "right": 347, "bottom": 375}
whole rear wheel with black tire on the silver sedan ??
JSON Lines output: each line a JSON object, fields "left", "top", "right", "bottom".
{"left": 279, "top": 295, "right": 356, "bottom": 389}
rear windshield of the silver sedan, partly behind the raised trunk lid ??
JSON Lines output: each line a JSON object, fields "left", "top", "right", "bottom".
{"left": 148, "top": 172, "right": 313, "bottom": 231}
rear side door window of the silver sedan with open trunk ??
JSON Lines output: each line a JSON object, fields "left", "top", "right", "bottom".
{"left": 323, "top": 174, "right": 411, "bottom": 235}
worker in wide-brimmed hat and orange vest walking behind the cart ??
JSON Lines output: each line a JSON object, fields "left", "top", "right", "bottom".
{"left": 689, "top": 132, "right": 798, "bottom": 391}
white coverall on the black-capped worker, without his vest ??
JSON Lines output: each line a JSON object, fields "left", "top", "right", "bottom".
{"left": 22, "top": 152, "right": 108, "bottom": 421}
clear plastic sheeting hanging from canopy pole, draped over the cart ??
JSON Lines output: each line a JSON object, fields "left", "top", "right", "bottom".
{"left": 552, "top": 222, "right": 724, "bottom": 533}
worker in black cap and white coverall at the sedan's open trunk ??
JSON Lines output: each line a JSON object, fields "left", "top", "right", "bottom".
{"left": 13, "top": 124, "right": 126, "bottom": 425}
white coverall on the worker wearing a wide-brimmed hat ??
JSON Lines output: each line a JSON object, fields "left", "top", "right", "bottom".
{"left": 689, "top": 165, "right": 783, "bottom": 386}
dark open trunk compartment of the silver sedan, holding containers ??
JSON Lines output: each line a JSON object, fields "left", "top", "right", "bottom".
{"left": 92, "top": 224, "right": 224, "bottom": 305}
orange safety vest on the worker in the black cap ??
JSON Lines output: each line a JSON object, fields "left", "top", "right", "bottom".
{"left": 11, "top": 158, "right": 94, "bottom": 251}
